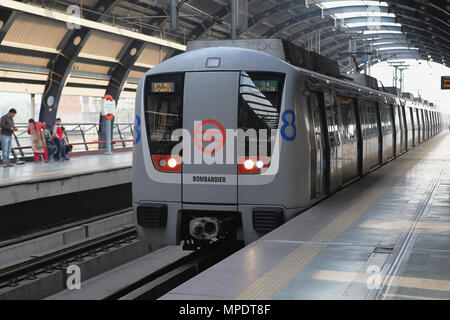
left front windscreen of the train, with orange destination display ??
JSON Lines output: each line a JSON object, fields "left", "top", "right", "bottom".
{"left": 145, "top": 74, "right": 184, "bottom": 155}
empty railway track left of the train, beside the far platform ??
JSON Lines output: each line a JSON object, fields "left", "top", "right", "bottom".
{"left": 0, "top": 227, "right": 137, "bottom": 289}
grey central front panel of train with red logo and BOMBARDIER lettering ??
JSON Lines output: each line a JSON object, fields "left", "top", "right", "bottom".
{"left": 182, "top": 72, "right": 240, "bottom": 204}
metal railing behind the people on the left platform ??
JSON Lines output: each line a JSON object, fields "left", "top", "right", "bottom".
{"left": 6, "top": 123, "right": 134, "bottom": 158}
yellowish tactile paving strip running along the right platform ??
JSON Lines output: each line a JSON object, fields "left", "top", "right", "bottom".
{"left": 235, "top": 135, "right": 446, "bottom": 300}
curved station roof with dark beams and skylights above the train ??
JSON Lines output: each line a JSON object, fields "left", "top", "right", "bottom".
{"left": 0, "top": 0, "right": 450, "bottom": 97}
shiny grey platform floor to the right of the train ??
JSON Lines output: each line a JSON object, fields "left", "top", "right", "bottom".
{"left": 162, "top": 133, "right": 450, "bottom": 300}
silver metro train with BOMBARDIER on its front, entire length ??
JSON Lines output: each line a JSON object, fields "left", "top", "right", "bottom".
{"left": 133, "top": 39, "right": 443, "bottom": 250}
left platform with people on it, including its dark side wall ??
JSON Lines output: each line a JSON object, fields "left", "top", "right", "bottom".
{"left": 0, "top": 152, "right": 132, "bottom": 240}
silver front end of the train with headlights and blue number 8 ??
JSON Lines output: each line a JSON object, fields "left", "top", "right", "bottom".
{"left": 133, "top": 47, "right": 309, "bottom": 249}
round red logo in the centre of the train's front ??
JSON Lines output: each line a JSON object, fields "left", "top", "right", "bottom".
{"left": 194, "top": 119, "right": 227, "bottom": 154}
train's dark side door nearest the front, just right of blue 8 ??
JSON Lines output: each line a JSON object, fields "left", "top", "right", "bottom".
{"left": 308, "top": 92, "right": 327, "bottom": 199}
